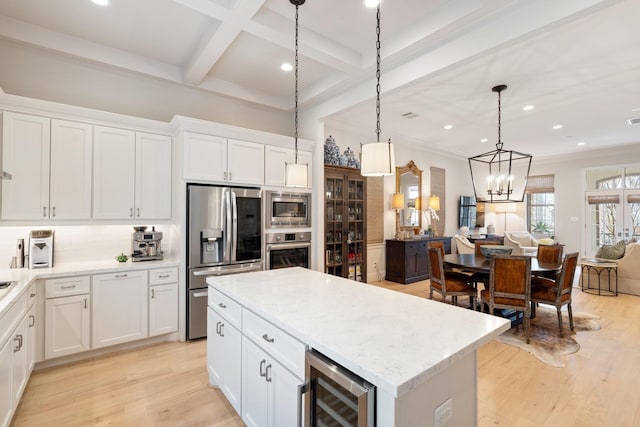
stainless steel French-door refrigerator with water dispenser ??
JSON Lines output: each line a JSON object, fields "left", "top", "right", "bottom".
{"left": 187, "top": 184, "right": 263, "bottom": 340}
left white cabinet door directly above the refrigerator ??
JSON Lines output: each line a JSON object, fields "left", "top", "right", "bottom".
{"left": 182, "top": 132, "right": 227, "bottom": 182}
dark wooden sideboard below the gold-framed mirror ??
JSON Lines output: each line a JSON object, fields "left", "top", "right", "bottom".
{"left": 385, "top": 237, "right": 451, "bottom": 284}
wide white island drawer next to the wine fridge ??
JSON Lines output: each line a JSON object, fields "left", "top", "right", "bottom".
{"left": 242, "top": 310, "right": 306, "bottom": 378}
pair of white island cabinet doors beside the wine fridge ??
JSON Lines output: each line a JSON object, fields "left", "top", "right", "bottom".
{"left": 242, "top": 337, "right": 302, "bottom": 427}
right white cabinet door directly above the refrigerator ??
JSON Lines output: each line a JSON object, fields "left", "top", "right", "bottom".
{"left": 227, "top": 139, "right": 264, "bottom": 185}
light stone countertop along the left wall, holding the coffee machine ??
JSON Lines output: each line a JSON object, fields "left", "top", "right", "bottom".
{"left": 0, "top": 259, "right": 180, "bottom": 317}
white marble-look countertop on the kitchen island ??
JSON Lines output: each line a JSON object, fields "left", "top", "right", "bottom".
{"left": 207, "top": 267, "right": 510, "bottom": 397}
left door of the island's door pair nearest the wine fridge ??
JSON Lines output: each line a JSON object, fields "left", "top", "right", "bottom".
{"left": 242, "top": 337, "right": 269, "bottom": 427}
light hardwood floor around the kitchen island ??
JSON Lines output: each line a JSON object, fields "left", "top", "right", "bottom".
{"left": 12, "top": 282, "right": 640, "bottom": 427}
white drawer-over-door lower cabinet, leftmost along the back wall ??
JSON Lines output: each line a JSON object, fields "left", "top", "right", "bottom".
{"left": 44, "top": 276, "right": 91, "bottom": 359}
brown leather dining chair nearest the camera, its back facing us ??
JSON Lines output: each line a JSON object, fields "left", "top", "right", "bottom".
{"left": 480, "top": 255, "right": 531, "bottom": 343}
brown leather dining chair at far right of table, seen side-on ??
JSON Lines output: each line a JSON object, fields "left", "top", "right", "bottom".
{"left": 531, "top": 252, "right": 578, "bottom": 336}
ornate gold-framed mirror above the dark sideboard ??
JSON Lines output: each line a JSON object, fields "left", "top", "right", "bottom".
{"left": 396, "top": 160, "right": 422, "bottom": 232}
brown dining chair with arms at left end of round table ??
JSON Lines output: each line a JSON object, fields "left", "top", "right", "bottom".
{"left": 429, "top": 246, "right": 477, "bottom": 307}
